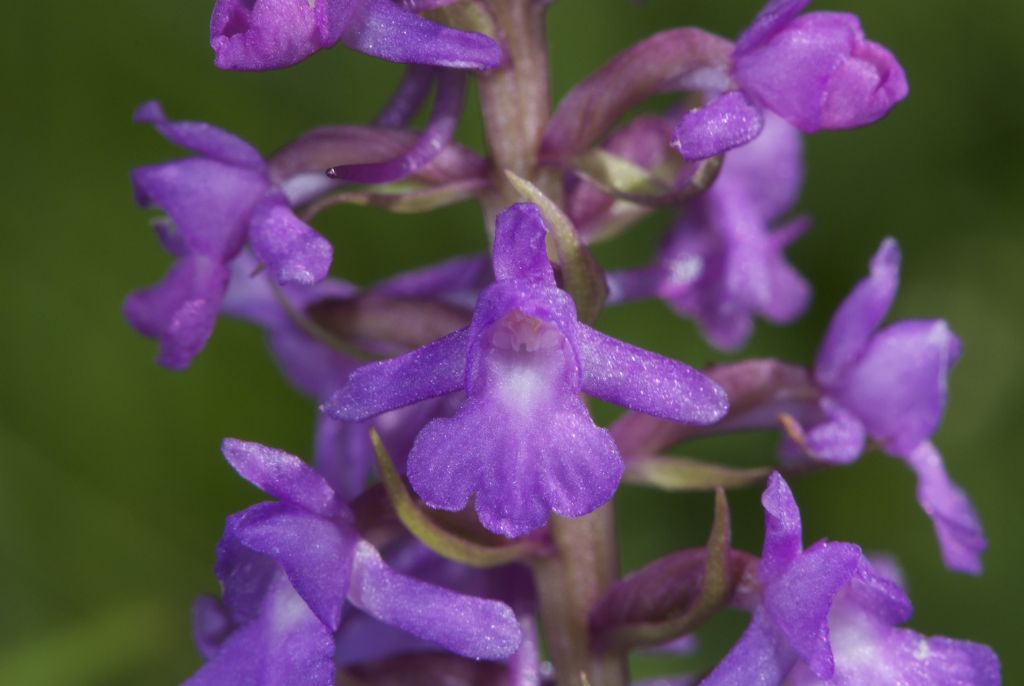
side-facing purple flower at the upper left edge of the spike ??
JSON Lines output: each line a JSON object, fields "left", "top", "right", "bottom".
{"left": 124, "top": 102, "right": 333, "bottom": 370}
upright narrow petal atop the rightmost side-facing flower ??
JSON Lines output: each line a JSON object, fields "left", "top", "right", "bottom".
{"left": 814, "top": 239, "right": 900, "bottom": 388}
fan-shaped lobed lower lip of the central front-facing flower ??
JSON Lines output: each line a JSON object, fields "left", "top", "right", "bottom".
{"left": 409, "top": 393, "right": 623, "bottom": 538}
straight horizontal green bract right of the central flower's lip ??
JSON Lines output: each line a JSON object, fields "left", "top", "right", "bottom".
{"left": 623, "top": 455, "right": 771, "bottom": 491}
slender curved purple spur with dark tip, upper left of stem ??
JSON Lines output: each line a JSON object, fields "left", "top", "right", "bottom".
{"left": 327, "top": 71, "right": 466, "bottom": 183}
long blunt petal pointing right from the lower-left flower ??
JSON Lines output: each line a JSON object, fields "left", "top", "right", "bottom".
{"left": 348, "top": 541, "right": 522, "bottom": 659}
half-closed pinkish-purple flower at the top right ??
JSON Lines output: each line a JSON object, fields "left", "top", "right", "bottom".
{"left": 673, "top": 0, "right": 908, "bottom": 160}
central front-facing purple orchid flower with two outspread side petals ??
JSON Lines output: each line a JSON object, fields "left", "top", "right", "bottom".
{"left": 325, "top": 204, "right": 727, "bottom": 538}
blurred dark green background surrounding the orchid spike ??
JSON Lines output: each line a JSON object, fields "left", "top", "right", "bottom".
{"left": 0, "top": 0, "right": 1024, "bottom": 686}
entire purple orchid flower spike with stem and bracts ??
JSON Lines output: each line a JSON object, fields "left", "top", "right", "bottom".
{"left": 124, "top": 0, "right": 1000, "bottom": 686}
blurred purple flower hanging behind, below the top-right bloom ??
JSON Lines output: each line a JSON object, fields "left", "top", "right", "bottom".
{"left": 608, "top": 113, "right": 810, "bottom": 350}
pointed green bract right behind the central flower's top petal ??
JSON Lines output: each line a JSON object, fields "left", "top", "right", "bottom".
{"left": 505, "top": 171, "right": 608, "bottom": 324}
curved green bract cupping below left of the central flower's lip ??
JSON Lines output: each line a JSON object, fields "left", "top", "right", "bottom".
{"left": 370, "top": 429, "right": 544, "bottom": 567}
